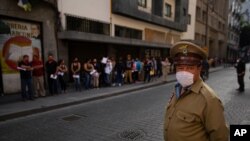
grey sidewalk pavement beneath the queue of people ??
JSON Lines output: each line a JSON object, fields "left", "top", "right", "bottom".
{"left": 0, "top": 66, "right": 224, "bottom": 122}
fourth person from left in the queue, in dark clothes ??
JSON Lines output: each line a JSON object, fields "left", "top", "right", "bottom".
{"left": 57, "top": 59, "right": 68, "bottom": 93}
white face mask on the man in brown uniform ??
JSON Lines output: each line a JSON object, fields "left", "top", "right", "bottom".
{"left": 176, "top": 71, "right": 194, "bottom": 87}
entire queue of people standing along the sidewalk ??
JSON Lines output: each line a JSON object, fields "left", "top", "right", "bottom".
{"left": 18, "top": 54, "right": 173, "bottom": 101}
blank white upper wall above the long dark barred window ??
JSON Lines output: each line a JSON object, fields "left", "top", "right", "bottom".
{"left": 58, "top": 0, "right": 111, "bottom": 29}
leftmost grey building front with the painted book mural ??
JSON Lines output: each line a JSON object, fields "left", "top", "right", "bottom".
{"left": 0, "top": 0, "right": 57, "bottom": 94}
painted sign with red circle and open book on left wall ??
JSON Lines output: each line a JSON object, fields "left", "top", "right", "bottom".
{"left": 0, "top": 18, "right": 41, "bottom": 93}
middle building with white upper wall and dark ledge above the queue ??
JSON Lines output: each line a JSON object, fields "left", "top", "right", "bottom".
{"left": 58, "top": 0, "right": 188, "bottom": 67}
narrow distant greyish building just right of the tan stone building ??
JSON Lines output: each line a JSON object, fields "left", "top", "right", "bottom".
{"left": 227, "top": 0, "right": 242, "bottom": 60}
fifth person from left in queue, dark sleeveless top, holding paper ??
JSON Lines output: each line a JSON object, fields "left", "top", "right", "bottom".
{"left": 70, "top": 57, "right": 81, "bottom": 91}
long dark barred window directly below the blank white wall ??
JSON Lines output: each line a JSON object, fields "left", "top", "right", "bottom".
{"left": 66, "top": 15, "right": 110, "bottom": 35}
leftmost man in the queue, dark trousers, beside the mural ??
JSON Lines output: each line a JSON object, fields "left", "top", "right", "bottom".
{"left": 18, "top": 55, "right": 34, "bottom": 101}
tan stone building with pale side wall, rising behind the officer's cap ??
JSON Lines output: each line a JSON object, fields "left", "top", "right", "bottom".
{"left": 182, "top": 0, "right": 228, "bottom": 58}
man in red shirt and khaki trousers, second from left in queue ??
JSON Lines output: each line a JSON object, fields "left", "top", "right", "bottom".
{"left": 31, "top": 55, "right": 46, "bottom": 97}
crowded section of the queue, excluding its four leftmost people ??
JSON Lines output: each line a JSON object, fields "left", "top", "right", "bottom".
{"left": 68, "top": 54, "right": 171, "bottom": 91}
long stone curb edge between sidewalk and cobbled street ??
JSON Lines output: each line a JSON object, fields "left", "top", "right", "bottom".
{"left": 0, "top": 68, "right": 224, "bottom": 122}
